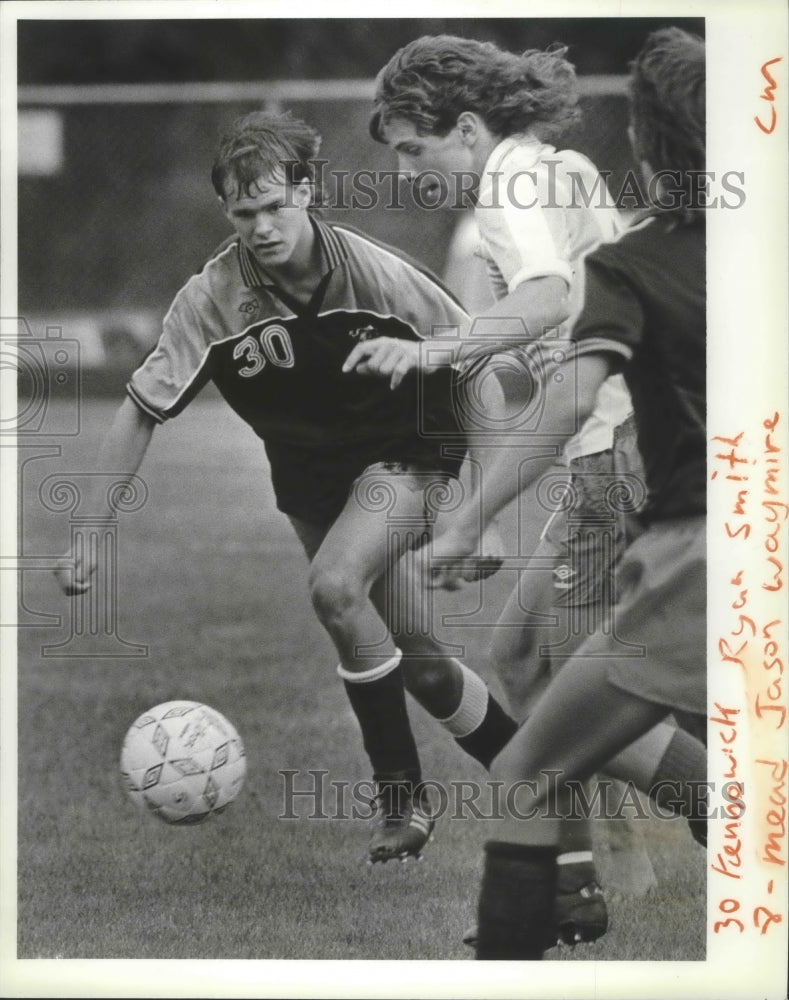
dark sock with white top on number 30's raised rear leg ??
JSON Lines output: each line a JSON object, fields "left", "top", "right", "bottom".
{"left": 438, "top": 660, "right": 518, "bottom": 767}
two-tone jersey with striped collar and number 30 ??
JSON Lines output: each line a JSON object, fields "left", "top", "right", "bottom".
{"left": 127, "top": 219, "right": 466, "bottom": 519}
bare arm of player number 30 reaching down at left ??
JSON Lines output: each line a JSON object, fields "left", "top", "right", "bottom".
{"left": 55, "top": 398, "right": 156, "bottom": 595}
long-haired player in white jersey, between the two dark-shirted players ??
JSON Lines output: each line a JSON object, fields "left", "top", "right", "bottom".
{"left": 346, "top": 29, "right": 706, "bottom": 943}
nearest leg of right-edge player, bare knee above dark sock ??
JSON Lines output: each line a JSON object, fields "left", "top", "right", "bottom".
{"left": 477, "top": 660, "right": 667, "bottom": 959}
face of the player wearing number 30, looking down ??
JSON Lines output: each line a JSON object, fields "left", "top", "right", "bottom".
{"left": 223, "top": 175, "right": 314, "bottom": 270}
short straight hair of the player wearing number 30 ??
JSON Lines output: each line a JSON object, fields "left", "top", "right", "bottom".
{"left": 211, "top": 111, "right": 321, "bottom": 198}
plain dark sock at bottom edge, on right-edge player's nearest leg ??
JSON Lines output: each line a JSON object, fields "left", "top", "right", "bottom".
{"left": 477, "top": 840, "right": 556, "bottom": 961}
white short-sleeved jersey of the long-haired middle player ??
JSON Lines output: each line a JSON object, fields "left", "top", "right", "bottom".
{"left": 475, "top": 135, "right": 632, "bottom": 460}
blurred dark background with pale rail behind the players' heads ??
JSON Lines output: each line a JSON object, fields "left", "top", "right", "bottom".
{"left": 18, "top": 18, "right": 704, "bottom": 391}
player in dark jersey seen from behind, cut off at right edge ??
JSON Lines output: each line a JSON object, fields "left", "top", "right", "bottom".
{"left": 435, "top": 28, "right": 706, "bottom": 959}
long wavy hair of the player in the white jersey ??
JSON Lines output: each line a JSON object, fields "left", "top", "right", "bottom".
{"left": 370, "top": 35, "right": 579, "bottom": 142}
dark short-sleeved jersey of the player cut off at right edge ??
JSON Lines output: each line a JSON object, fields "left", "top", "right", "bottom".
{"left": 573, "top": 216, "right": 706, "bottom": 523}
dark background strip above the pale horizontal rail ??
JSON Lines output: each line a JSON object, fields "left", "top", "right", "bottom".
{"left": 18, "top": 18, "right": 704, "bottom": 84}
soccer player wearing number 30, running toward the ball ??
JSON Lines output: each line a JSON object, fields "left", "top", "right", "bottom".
{"left": 59, "top": 112, "right": 516, "bottom": 861}
